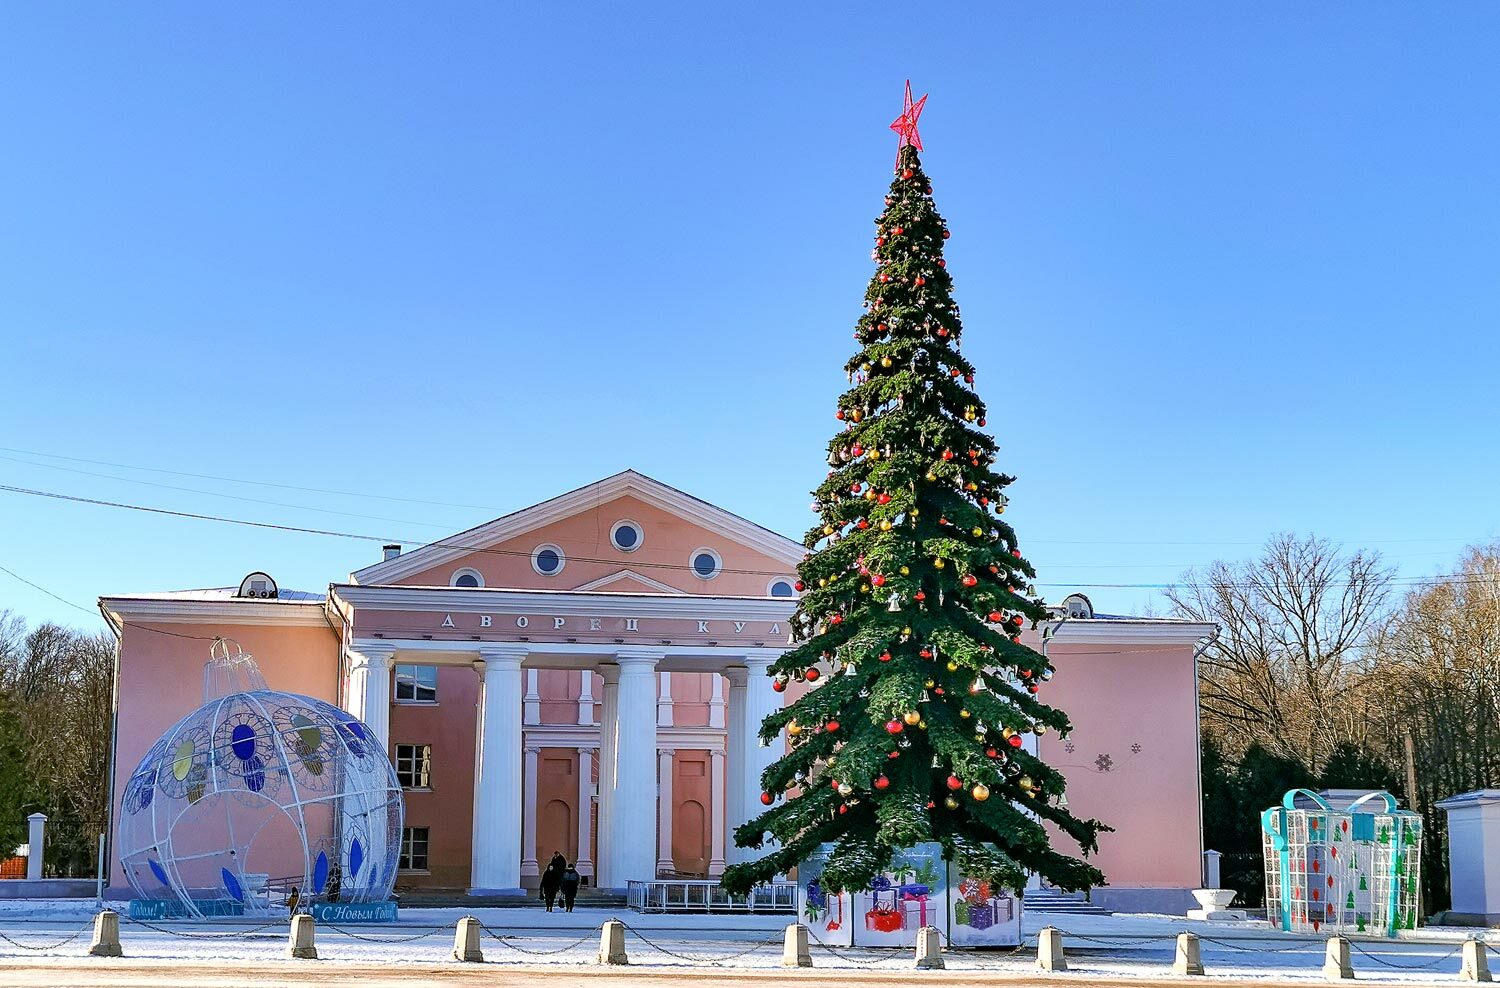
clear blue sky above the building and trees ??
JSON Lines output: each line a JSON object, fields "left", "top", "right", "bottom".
{"left": 0, "top": 3, "right": 1500, "bottom": 625}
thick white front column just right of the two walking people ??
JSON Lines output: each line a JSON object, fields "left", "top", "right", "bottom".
{"left": 603, "top": 648, "right": 662, "bottom": 889}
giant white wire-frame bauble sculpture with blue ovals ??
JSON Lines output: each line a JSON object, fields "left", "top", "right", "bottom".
{"left": 120, "top": 640, "right": 404, "bottom": 918}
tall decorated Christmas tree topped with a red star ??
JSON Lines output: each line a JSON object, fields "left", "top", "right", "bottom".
{"left": 723, "top": 84, "right": 1109, "bottom": 892}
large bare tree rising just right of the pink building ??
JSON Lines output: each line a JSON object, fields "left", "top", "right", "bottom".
{"left": 1167, "top": 534, "right": 1392, "bottom": 772}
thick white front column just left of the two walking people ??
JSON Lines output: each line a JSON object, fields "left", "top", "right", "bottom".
{"left": 470, "top": 642, "right": 527, "bottom": 894}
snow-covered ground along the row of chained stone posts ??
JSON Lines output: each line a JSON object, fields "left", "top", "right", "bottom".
{"left": 0, "top": 900, "right": 1500, "bottom": 984}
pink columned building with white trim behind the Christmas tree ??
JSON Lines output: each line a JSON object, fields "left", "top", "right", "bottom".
{"left": 101, "top": 471, "right": 1212, "bottom": 909}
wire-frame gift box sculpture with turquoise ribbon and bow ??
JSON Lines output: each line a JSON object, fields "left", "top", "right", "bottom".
{"left": 1260, "top": 789, "right": 1422, "bottom": 937}
